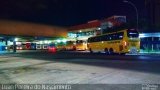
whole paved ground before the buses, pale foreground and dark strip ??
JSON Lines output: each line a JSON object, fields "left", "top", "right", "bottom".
{"left": 0, "top": 51, "right": 160, "bottom": 90}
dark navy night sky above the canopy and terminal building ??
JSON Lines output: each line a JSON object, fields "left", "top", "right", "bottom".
{"left": 0, "top": 0, "right": 144, "bottom": 26}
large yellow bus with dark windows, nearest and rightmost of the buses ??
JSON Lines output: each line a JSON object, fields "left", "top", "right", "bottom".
{"left": 88, "top": 29, "right": 140, "bottom": 54}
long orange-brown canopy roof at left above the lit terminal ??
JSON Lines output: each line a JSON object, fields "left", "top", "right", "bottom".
{"left": 0, "top": 20, "right": 67, "bottom": 37}
